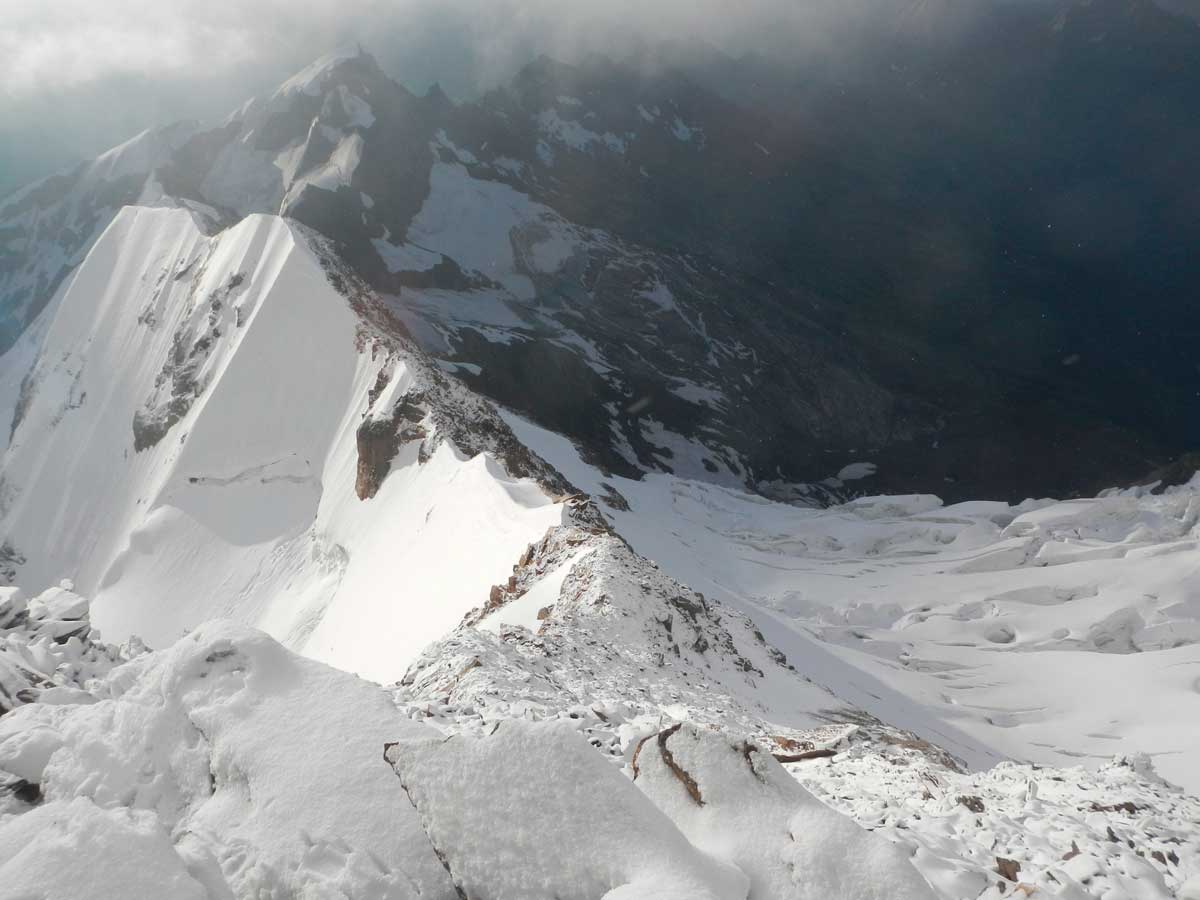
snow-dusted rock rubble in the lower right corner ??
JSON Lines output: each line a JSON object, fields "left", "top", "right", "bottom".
{"left": 787, "top": 740, "right": 1200, "bottom": 900}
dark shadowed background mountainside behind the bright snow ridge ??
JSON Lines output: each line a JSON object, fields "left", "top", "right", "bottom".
{"left": 0, "top": 0, "right": 1200, "bottom": 502}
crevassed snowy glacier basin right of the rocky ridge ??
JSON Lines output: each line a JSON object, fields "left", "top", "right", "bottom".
{"left": 509, "top": 418, "right": 1200, "bottom": 791}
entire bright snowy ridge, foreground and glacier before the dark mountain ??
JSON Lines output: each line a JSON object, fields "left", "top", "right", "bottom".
{"left": 0, "top": 181, "right": 1200, "bottom": 898}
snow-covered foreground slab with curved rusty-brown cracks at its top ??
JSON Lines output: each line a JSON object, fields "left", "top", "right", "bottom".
{"left": 632, "top": 725, "right": 934, "bottom": 900}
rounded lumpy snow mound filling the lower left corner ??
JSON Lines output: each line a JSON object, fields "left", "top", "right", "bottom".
{"left": 0, "top": 623, "right": 454, "bottom": 899}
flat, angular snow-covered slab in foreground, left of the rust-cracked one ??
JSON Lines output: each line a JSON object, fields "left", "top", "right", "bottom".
{"left": 386, "top": 720, "right": 746, "bottom": 900}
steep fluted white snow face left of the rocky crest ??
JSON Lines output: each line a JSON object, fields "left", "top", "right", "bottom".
{"left": 0, "top": 208, "right": 562, "bottom": 680}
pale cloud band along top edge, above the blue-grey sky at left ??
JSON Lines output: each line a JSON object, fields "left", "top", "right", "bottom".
{"left": 0, "top": 0, "right": 907, "bottom": 101}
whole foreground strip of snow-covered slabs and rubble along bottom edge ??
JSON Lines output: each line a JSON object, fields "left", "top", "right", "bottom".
{"left": 0, "top": 593, "right": 1200, "bottom": 900}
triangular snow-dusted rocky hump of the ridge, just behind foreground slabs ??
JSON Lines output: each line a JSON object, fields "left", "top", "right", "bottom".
{"left": 397, "top": 520, "right": 835, "bottom": 750}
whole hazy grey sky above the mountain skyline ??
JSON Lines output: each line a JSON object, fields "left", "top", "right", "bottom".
{"left": 0, "top": 0, "right": 1200, "bottom": 196}
